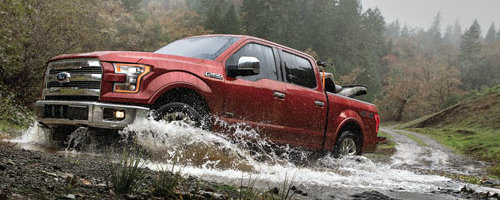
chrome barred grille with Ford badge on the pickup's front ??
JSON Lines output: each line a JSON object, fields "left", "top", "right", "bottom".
{"left": 43, "top": 59, "right": 102, "bottom": 100}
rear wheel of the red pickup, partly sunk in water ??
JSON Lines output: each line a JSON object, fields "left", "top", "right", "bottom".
{"left": 333, "top": 131, "right": 361, "bottom": 158}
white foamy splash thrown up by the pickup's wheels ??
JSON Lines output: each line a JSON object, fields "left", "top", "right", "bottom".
{"left": 11, "top": 119, "right": 500, "bottom": 193}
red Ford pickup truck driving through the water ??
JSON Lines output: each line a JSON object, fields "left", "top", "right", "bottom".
{"left": 35, "top": 35, "right": 379, "bottom": 155}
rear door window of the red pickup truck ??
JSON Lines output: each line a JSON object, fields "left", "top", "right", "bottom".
{"left": 282, "top": 51, "right": 316, "bottom": 88}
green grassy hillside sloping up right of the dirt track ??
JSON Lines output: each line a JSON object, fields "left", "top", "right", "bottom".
{"left": 400, "top": 86, "right": 500, "bottom": 175}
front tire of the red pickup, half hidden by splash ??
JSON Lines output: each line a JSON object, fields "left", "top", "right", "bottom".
{"left": 155, "top": 102, "right": 210, "bottom": 129}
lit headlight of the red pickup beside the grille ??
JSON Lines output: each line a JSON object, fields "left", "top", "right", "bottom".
{"left": 113, "top": 63, "right": 149, "bottom": 92}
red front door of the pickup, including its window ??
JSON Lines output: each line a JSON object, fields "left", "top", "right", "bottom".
{"left": 224, "top": 42, "right": 286, "bottom": 139}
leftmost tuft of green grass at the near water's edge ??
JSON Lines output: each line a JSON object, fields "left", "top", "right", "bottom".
{"left": 108, "top": 148, "right": 144, "bottom": 194}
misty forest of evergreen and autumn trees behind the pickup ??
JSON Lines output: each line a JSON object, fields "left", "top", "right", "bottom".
{"left": 0, "top": 0, "right": 500, "bottom": 124}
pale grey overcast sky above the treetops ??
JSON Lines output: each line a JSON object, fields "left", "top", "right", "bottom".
{"left": 361, "top": 0, "right": 500, "bottom": 35}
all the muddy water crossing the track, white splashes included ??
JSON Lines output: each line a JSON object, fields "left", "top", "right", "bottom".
{"left": 8, "top": 119, "right": 498, "bottom": 199}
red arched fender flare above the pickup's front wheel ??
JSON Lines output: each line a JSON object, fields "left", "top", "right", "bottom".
{"left": 148, "top": 71, "right": 212, "bottom": 104}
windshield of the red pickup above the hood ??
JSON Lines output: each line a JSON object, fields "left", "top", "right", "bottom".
{"left": 155, "top": 36, "right": 240, "bottom": 60}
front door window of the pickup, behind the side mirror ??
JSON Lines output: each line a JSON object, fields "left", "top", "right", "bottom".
{"left": 226, "top": 43, "right": 278, "bottom": 81}
